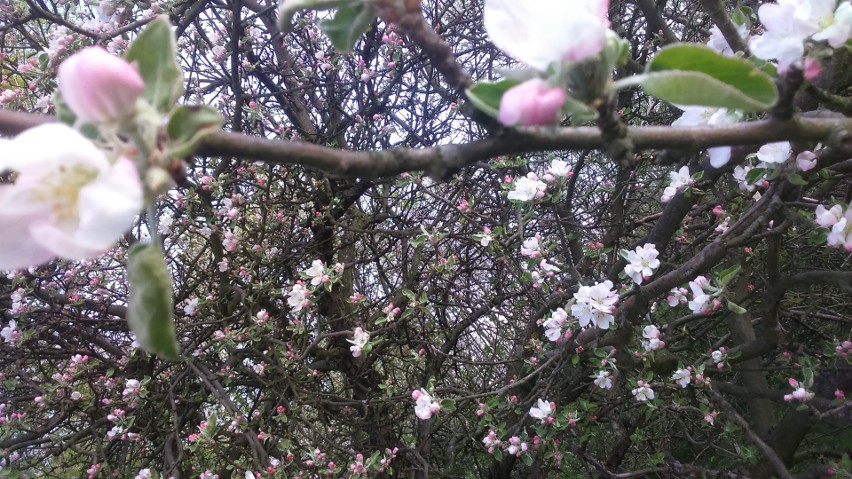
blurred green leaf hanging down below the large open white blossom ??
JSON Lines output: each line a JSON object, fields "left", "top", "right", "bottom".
{"left": 127, "top": 243, "right": 179, "bottom": 360}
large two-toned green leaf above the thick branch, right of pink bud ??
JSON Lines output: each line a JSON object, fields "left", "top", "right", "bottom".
{"left": 635, "top": 43, "right": 778, "bottom": 111}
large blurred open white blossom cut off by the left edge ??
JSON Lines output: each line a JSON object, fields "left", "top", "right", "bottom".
{"left": 0, "top": 123, "right": 143, "bottom": 270}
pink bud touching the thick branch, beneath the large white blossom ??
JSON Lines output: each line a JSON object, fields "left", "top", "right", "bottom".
{"left": 497, "top": 78, "right": 568, "bottom": 126}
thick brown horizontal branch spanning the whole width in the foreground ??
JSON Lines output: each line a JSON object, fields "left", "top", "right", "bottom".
{"left": 0, "top": 111, "right": 852, "bottom": 178}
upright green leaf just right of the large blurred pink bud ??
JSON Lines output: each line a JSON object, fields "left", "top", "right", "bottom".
{"left": 124, "top": 16, "right": 183, "bottom": 113}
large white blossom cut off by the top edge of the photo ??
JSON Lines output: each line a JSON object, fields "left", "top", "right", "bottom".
{"left": 483, "top": 0, "right": 609, "bottom": 71}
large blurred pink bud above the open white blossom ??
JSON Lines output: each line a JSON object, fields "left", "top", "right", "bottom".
{"left": 58, "top": 47, "right": 145, "bottom": 123}
